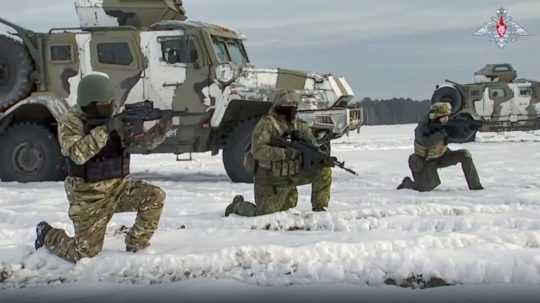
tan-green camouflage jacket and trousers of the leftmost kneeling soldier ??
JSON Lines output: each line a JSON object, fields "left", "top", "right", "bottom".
{"left": 44, "top": 75, "right": 171, "bottom": 262}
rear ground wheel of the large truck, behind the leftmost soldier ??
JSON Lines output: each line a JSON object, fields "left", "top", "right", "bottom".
{"left": 0, "top": 123, "right": 65, "bottom": 182}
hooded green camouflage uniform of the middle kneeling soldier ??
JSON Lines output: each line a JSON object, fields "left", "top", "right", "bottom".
{"left": 228, "top": 91, "right": 332, "bottom": 217}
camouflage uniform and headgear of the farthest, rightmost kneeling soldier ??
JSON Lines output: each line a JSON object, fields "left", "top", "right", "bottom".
{"left": 398, "top": 103, "right": 483, "bottom": 192}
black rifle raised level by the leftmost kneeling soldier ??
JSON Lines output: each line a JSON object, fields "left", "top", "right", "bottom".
{"left": 88, "top": 101, "right": 182, "bottom": 137}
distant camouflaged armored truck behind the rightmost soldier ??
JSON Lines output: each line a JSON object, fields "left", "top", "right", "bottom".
{"left": 431, "top": 64, "right": 540, "bottom": 142}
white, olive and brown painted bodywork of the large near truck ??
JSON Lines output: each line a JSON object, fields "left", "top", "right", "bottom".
{"left": 3, "top": 0, "right": 361, "bottom": 164}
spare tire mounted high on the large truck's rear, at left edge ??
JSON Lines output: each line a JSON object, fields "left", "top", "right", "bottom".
{"left": 0, "top": 35, "right": 33, "bottom": 109}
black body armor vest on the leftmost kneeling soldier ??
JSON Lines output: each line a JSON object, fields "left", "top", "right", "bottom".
{"left": 67, "top": 132, "right": 130, "bottom": 182}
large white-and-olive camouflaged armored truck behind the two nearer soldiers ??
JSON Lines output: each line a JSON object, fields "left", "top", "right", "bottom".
{"left": 0, "top": 0, "right": 362, "bottom": 182}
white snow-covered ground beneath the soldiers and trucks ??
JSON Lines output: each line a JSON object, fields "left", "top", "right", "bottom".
{"left": 0, "top": 125, "right": 540, "bottom": 301}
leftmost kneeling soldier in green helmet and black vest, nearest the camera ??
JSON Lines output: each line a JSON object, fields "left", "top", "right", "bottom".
{"left": 35, "top": 73, "right": 172, "bottom": 262}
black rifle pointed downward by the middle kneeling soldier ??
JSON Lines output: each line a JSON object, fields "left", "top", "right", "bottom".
{"left": 270, "top": 136, "right": 359, "bottom": 176}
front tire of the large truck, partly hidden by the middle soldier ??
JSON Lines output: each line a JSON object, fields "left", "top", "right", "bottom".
{"left": 223, "top": 119, "right": 257, "bottom": 183}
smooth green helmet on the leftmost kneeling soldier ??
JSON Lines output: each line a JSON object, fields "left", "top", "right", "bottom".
{"left": 77, "top": 73, "right": 114, "bottom": 107}
